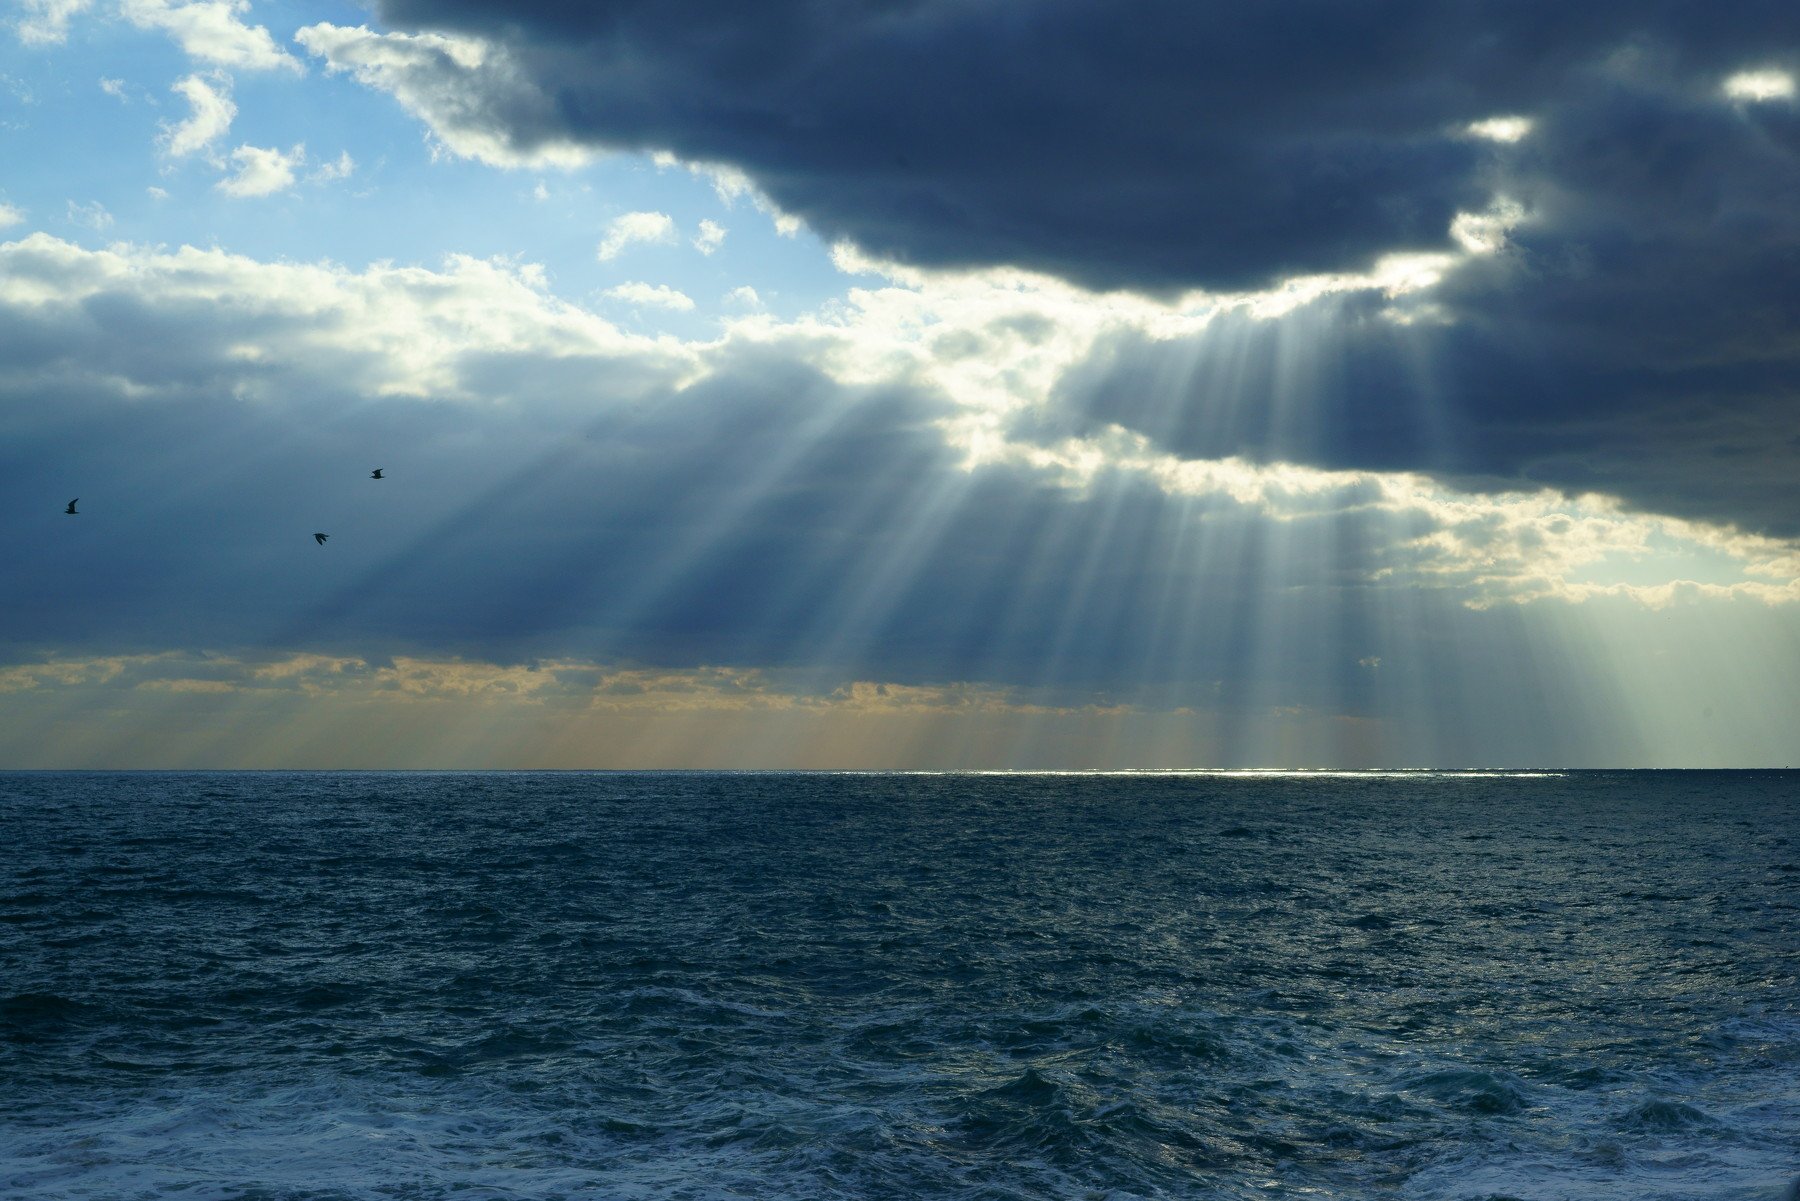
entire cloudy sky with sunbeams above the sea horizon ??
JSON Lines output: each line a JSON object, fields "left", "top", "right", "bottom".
{"left": 0, "top": 0, "right": 1800, "bottom": 769}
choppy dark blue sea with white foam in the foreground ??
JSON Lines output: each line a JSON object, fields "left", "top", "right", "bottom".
{"left": 0, "top": 772, "right": 1800, "bottom": 1201}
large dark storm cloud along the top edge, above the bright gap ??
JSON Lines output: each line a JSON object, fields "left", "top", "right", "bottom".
{"left": 365, "top": 0, "right": 1800, "bottom": 288}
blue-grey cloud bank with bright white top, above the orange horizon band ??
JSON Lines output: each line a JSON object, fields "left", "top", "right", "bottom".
{"left": 0, "top": 234, "right": 1800, "bottom": 651}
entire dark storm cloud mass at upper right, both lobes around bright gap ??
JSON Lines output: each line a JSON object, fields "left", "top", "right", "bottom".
{"left": 320, "top": 0, "right": 1800, "bottom": 533}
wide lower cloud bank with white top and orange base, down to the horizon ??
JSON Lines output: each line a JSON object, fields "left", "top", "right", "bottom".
{"left": 0, "top": 234, "right": 1800, "bottom": 765}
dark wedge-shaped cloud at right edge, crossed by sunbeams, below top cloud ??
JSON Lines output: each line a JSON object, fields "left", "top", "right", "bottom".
{"left": 1060, "top": 67, "right": 1800, "bottom": 537}
